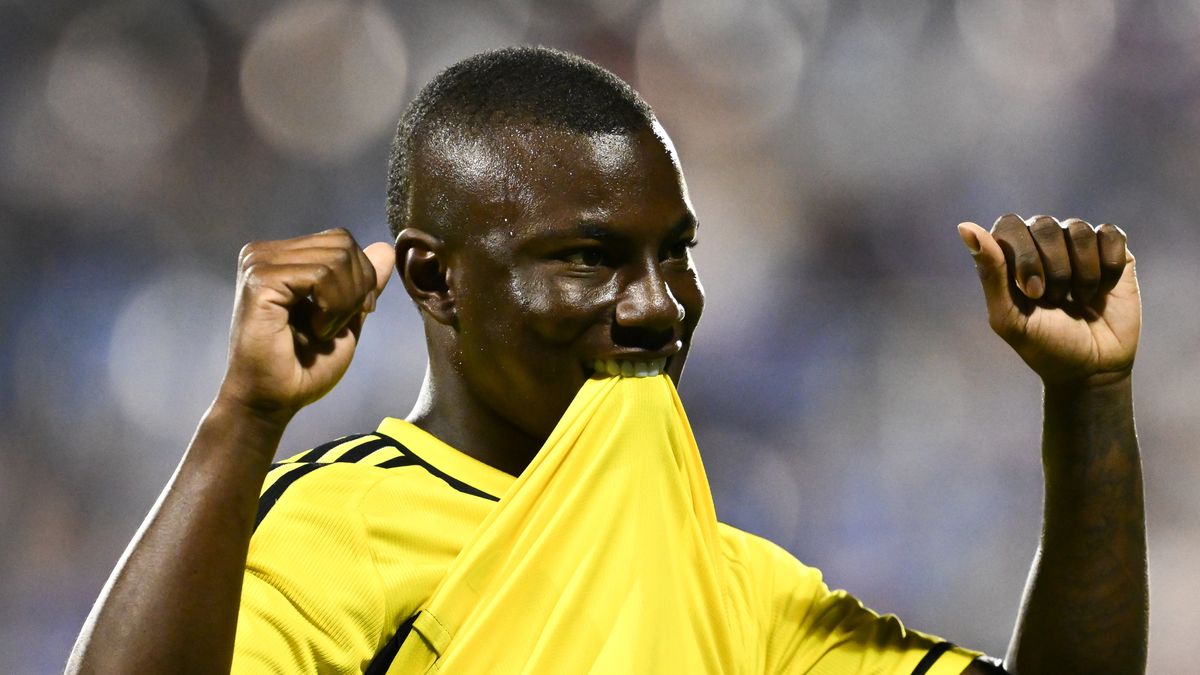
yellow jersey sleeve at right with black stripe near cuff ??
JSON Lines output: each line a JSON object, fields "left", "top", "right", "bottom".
{"left": 748, "top": 528, "right": 979, "bottom": 675}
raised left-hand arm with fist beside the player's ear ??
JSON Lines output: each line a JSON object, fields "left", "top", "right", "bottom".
{"left": 67, "top": 229, "right": 395, "bottom": 673}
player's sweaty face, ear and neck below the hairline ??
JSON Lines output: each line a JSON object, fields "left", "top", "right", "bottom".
{"left": 396, "top": 125, "right": 704, "bottom": 474}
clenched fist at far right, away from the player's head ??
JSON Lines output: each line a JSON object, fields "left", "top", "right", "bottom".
{"left": 959, "top": 214, "right": 1141, "bottom": 384}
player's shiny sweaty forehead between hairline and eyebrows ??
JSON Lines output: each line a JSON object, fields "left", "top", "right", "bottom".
{"left": 432, "top": 123, "right": 691, "bottom": 234}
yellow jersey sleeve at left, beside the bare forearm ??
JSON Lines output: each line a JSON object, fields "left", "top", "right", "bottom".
{"left": 232, "top": 464, "right": 388, "bottom": 674}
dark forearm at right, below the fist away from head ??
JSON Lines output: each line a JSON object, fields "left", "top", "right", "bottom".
{"left": 1006, "top": 376, "right": 1148, "bottom": 675}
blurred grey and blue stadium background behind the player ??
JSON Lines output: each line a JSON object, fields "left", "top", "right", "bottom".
{"left": 0, "top": 0, "right": 1200, "bottom": 674}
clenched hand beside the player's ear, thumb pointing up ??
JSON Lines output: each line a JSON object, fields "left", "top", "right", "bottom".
{"left": 217, "top": 229, "right": 396, "bottom": 424}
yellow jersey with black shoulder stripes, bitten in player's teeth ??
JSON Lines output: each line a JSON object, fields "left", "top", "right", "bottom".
{"left": 234, "top": 376, "right": 978, "bottom": 675}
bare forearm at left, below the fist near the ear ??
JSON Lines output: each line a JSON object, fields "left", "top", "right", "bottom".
{"left": 67, "top": 396, "right": 286, "bottom": 673}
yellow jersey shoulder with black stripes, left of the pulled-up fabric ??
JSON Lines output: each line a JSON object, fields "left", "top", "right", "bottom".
{"left": 238, "top": 431, "right": 496, "bottom": 670}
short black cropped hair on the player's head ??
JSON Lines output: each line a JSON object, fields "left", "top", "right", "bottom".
{"left": 388, "top": 47, "right": 654, "bottom": 238}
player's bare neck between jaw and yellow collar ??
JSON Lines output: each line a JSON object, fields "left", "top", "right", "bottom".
{"left": 404, "top": 364, "right": 546, "bottom": 476}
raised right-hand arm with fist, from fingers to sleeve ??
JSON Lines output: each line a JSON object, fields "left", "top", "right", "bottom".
{"left": 959, "top": 215, "right": 1148, "bottom": 675}
